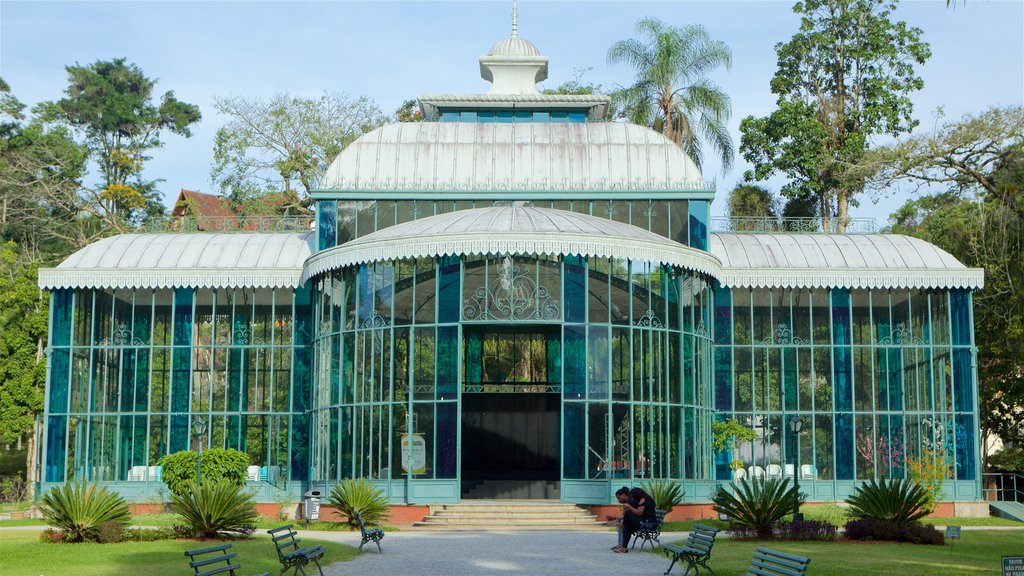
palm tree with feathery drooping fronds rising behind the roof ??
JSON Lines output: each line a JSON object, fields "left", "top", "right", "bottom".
{"left": 608, "top": 17, "right": 733, "bottom": 170}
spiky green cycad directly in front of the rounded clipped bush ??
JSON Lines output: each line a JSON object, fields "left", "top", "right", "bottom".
{"left": 171, "top": 480, "right": 259, "bottom": 538}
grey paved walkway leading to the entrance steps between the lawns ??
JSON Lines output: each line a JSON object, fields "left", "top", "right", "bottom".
{"left": 303, "top": 531, "right": 686, "bottom": 576}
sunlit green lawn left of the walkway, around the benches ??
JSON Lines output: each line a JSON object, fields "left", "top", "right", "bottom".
{"left": 0, "top": 531, "right": 358, "bottom": 576}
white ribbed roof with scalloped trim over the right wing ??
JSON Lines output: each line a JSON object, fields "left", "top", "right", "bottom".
{"left": 710, "top": 234, "right": 984, "bottom": 289}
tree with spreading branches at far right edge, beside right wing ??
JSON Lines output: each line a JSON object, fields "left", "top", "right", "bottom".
{"left": 880, "top": 107, "right": 1024, "bottom": 467}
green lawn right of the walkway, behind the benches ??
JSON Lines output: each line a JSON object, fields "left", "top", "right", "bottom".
{"left": 659, "top": 530, "right": 1024, "bottom": 576}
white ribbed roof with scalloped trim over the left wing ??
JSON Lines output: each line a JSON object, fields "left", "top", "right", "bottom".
{"left": 39, "top": 233, "right": 313, "bottom": 289}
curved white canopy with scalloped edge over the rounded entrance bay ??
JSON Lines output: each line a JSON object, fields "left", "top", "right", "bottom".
{"left": 302, "top": 206, "right": 719, "bottom": 282}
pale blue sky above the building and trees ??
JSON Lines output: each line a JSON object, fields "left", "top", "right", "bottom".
{"left": 0, "top": 0, "right": 1024, "bottom": 223}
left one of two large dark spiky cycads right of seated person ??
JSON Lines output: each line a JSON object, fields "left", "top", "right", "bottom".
{"left": 713, "top": 479, "right": 804, "bottom": 538}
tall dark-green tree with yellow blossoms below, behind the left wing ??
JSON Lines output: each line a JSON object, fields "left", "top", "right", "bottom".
{"left": 39, "top": 58, "right": 202, "bottom": 227}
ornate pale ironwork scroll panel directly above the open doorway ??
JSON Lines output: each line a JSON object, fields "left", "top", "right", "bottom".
{"left": 462, "top": 256, "right": 561, "bottom": 320}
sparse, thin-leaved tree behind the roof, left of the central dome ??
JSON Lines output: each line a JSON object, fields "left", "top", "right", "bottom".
{"left": 210, "top": 88, "right": 385, "bottom": 208}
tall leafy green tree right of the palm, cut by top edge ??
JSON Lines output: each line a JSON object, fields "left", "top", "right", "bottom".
{"left": 739, "top": 0, "right": 931, "bottom": 232}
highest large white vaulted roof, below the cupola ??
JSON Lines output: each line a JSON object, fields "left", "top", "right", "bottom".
{"left": 319, "top": 122, "right": 707, "bottom": 193}
